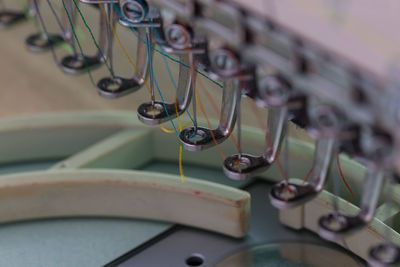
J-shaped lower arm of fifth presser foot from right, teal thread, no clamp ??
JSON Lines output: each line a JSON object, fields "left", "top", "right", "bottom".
{"left": 179, "top": 78, "right": 241, "bottom": 151}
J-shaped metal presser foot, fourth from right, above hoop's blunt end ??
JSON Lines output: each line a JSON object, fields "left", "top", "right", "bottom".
{"left": 223, "top": 106, "right": 288, "bottom": 180}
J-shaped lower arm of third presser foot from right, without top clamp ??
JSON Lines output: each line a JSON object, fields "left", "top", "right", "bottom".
{"left": 269, "top": 137, "right": 336, "bottom": 209}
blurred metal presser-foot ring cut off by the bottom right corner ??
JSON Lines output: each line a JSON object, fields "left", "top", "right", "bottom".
{"left": 368, "top": 242, "right": 400, "bottom": 267}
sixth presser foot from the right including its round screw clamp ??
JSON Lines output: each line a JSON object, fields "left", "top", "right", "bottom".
{"left": 138, "top": 23, "right": 207, "bottom": 125}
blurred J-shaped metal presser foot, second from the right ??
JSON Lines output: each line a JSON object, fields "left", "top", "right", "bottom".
{"left": 318, "top": 166, "right": 384, "bottom": 240}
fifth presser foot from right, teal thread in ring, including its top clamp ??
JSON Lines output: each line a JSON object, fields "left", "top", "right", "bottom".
{"left": 179, "top": 48, "right": 254, "bottom": 151}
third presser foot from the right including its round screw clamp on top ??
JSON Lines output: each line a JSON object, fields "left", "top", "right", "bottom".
{"left": 269, "top": 105, "right": 342, "bottom": 209}
